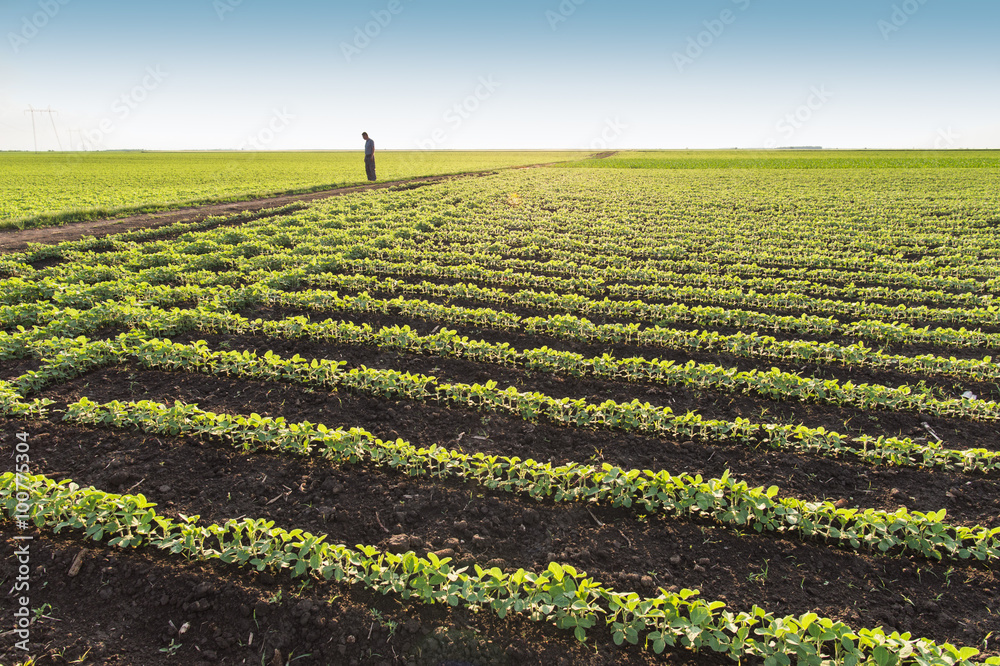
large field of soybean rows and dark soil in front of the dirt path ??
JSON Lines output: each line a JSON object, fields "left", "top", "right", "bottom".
{"left": 0, "top": 162, "right": 1000, "bottom": 664}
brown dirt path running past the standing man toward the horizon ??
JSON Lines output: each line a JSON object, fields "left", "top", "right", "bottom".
{"left": 0, "top": 152, "right": 615, "bottom": 253}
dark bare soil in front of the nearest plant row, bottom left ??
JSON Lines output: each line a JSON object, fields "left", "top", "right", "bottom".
{"left": 0, "top": 525, "right": 708, "bottom": 666}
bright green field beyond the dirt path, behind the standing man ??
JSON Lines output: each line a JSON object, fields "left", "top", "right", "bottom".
{"left": 0, "top": 151, "right": 588, "bottom": 228}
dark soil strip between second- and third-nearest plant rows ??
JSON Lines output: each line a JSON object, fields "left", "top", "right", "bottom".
{"left": 31, "top": 366, "right": 1000, "bottom": 527}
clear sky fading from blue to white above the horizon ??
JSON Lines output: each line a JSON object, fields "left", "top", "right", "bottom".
{"left": 0, "top": 0, "right": 1000, "bottom": 150}
